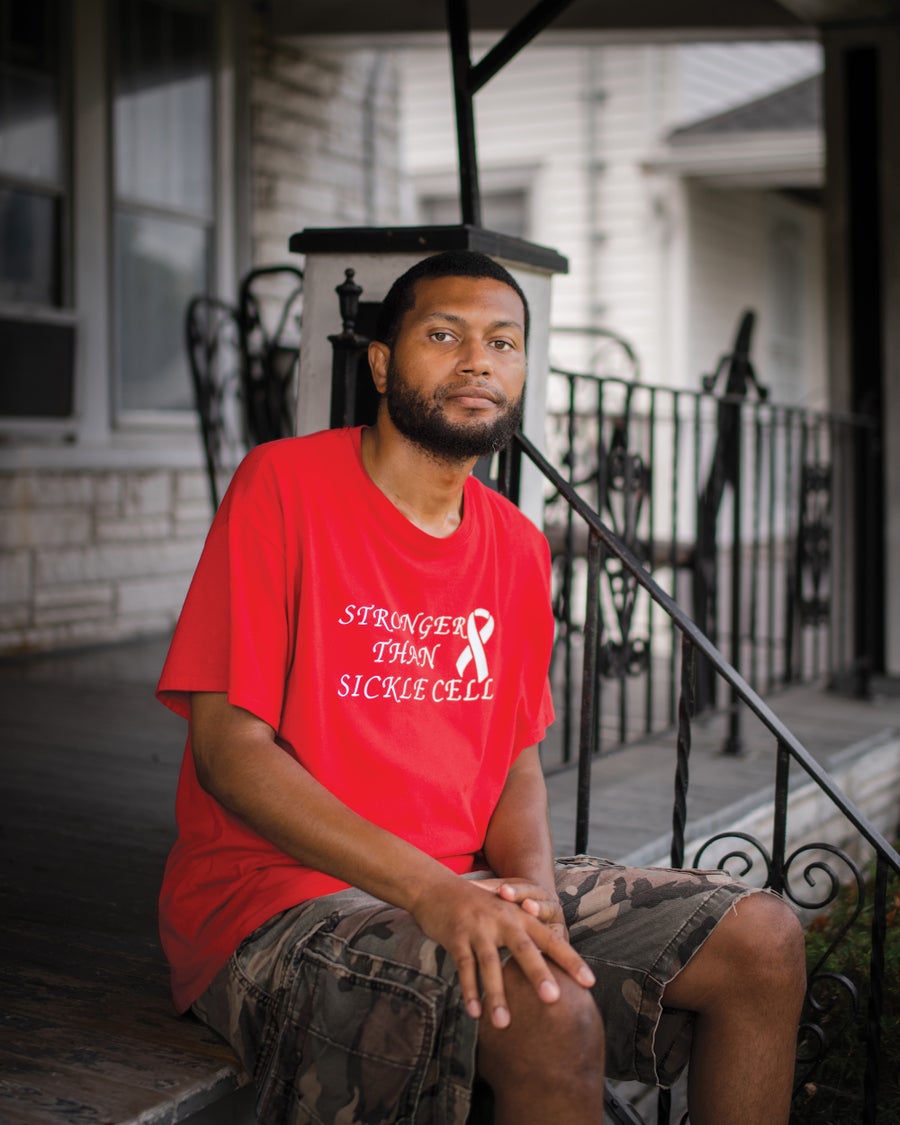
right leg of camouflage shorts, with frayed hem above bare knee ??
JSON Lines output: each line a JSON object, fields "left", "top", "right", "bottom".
{"left": 556, "top": 856, "right": 753, "bottom": 1086}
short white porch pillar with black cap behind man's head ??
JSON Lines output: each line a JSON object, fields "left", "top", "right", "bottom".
{"left": 289, "top": 225, "right": 568, "bottom": 527}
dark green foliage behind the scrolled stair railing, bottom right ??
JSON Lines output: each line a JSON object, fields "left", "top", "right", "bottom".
{"left": 791, "top": 850, "right": 900, "bottom": 1125}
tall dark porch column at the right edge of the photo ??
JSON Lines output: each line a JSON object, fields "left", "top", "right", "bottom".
{"left": 822, "top": 21, "right": 900, "bottom": 690}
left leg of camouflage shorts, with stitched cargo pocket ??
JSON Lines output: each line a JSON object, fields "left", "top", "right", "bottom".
{"left": 195, "top": 890, "right": 477, "bottom": 1125}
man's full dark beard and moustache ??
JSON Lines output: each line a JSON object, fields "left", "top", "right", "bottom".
{"left": 385, "top": 356, "right": 522, "bottom": 461}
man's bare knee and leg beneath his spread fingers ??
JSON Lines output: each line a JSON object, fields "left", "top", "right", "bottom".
{"left": 477, "top": 961, "right": 605, "bottom": 1125}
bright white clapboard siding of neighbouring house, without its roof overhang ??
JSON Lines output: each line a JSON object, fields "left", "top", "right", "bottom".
{"left": 402, "top": 43, "right": 821, "bottom": 387}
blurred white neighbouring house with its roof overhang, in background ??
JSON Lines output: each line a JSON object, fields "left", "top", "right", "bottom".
{"left": 401, "top": 43, "right": 826, "bottom": 406}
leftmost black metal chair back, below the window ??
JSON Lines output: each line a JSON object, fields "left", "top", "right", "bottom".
{"left": 185, "top": 296, "right": 250, "bottom": 511}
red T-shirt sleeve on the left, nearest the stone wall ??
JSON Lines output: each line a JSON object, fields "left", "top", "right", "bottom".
{"left": 156, "top": 447, "right": 299, "bottom": 729}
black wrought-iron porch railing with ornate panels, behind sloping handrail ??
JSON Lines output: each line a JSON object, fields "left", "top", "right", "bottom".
{"left": 546, "top": 368, "right": 874, "bottom": 765}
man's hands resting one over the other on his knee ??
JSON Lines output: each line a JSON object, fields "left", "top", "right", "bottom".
{"left": 413, "top": 876, "right": 594, "bottom": 1028}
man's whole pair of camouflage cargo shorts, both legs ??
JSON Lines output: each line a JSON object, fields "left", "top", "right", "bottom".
{"left": 194, "top": 856, "right": 752, "bottom": 1125}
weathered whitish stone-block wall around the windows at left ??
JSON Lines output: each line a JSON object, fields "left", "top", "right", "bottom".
{"left": 0, "top": 30, "right": 399, "bottom": 654}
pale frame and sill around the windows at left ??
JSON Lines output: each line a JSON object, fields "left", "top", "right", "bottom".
{"left": 0, "top": 0, "right": 238, "bottom": 459}
